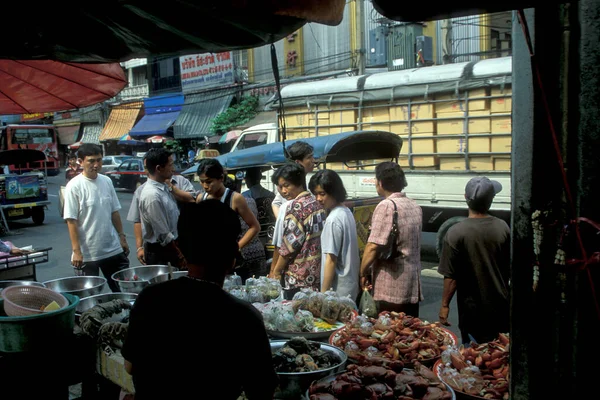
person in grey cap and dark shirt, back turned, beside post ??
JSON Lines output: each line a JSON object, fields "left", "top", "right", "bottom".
{"left": 438, "top": 177, "right": 510, "bottom": 345}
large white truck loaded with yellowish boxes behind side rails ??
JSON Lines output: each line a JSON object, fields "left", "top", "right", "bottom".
{"left": 231, "top": 57, "right": 512, "bottom": 250}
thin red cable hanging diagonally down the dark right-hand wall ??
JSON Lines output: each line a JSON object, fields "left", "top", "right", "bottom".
{"left": 517, "top": 9, "right": 600, "bottom": 319}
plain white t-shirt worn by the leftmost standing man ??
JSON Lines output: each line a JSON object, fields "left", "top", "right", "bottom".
{"left": 63, "top": 174, "right": 123, "bottom": 262}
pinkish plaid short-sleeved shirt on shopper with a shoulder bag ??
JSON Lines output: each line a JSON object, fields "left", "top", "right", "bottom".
{"left": 369, "top": 193, "right": 423, "bottom": 304}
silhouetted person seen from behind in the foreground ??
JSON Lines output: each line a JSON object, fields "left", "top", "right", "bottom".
{"left": 122, "top": 200, "right": 277, "bottom": 400}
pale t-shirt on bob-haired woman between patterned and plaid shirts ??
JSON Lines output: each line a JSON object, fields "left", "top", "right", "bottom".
{"left": 321, "top": 206, "right": 360, "bottom": 301}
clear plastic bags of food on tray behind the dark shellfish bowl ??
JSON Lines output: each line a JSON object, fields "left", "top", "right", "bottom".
{"left": 254, "top": 289, "right": 356, "bottom": 339}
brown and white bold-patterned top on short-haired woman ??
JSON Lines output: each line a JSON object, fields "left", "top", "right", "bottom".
{"left": 279, "top": 191, "right": 327, "bottom": 291}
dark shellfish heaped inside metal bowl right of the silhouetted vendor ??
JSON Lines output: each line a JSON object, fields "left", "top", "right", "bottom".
{"left": 273, "top": 337, "right": 342, "bottom": 373}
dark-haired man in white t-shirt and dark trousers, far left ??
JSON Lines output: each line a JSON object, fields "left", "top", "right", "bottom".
{"left": 63, "top": 143, "right": 129, "bottom": 292}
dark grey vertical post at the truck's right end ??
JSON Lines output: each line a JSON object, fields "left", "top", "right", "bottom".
{"left": 510, "top": 9, "right": 536, "bottom": 400}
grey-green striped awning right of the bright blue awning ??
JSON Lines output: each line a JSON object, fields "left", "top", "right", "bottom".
{"left": 173, "top": 89, "right": 236, "bottom": 139}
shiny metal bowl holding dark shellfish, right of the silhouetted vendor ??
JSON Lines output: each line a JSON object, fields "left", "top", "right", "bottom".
{"left": 270, "top": 340, "right": 348, "bottom": 399}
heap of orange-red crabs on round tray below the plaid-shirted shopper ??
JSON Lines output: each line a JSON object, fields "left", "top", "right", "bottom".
{"left": 329, "top": 311, "right": 458, "bottom": 366}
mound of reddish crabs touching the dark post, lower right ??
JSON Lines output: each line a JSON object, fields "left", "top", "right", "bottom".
{"left": 434, "top": 333, "right": 510, "bottom": 400}
